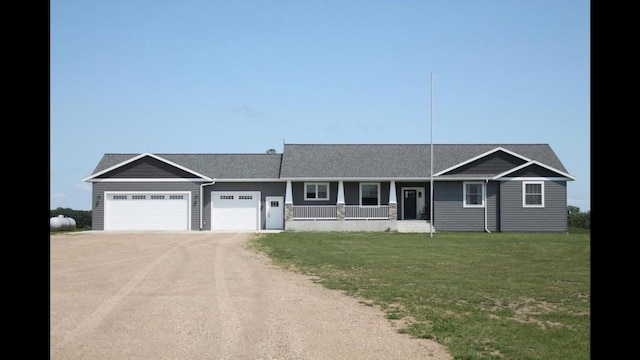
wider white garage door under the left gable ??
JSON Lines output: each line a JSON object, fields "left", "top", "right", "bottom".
{"left": 104, "top": 192, "right": 189, "bottom": 230}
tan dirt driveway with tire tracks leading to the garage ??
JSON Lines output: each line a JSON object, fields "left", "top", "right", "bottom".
{"left": 50, "top": 232, "right": 451, "bottom": 360}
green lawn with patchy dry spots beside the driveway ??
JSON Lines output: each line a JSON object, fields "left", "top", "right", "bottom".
{"left": 249, "top": 231, "right": 591, "bottom": 360}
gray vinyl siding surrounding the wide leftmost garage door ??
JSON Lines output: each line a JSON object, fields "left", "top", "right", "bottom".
{"left": 91, "top": 181, "right": 200, "bottom": 230}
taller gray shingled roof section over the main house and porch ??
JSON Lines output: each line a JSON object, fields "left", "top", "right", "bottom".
{"left": 280, "top": 144, "right": 566, "bottom": 178}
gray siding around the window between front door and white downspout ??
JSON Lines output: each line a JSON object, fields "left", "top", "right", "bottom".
{"left": 433, "top": 181, "right": 484, "bottom": 231}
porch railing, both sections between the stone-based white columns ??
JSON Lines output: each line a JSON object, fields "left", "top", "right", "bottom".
{"left": 293, "top": 205, "right": 389, "bottom": 220}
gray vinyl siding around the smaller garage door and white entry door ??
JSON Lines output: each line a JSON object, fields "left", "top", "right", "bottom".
{"left": 198, "top": 182, "right": 287, "bottom": 230}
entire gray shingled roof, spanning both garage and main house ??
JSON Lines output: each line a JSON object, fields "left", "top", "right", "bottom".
{"left": 90, "top": 144, "right": 567, "bottom": 180}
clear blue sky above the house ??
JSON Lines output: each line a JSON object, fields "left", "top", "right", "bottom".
{"left": 50, "top": 0, "right": 591, "bottom": 211}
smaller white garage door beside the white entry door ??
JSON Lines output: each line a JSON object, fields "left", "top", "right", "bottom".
{"left": 211, "top": 191, "right": 260, "bottom": 231}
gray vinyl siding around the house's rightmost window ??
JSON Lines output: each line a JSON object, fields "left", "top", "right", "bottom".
{"left": 500, "top": 180, "right": 567, "bottom": 232}
